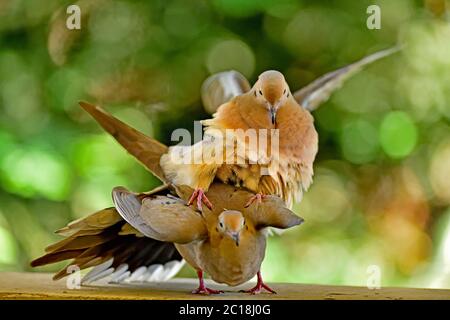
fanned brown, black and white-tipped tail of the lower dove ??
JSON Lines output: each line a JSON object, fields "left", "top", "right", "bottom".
{"left": 31, "top": 208, "right": 184, "bottom": 283}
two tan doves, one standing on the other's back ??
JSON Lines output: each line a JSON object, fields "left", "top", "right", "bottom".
{"left": 32, "top": 49, "right": 397, "bottom": 294}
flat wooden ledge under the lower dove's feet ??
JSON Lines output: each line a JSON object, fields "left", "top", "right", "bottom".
{"left": 0, "top": 272, "right": 450, "bottom": 300}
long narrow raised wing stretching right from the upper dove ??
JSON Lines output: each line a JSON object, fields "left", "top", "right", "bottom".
{"left": 294, "top": 47, "right": 401, "bottom": 111}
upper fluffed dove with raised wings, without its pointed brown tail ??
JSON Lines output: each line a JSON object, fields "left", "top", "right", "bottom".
{"left": 161, "top": 48, "right": 399, "bottom": 208}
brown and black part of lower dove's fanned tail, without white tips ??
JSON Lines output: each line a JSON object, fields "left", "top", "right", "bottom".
{"left": 31, "top": 201, "right": 181, "bottom": 280}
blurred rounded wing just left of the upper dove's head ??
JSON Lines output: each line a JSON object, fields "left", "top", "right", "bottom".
{"left": 201, "top": 70, "right": 251, "bottom": 114}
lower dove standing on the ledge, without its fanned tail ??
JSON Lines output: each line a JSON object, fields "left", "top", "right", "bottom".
{"left": 113, "top": 182, "right": 303, "bottom": 294}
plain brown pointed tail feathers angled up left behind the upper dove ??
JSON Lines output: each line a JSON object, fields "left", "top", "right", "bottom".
{"left": 80, "top": 102, "right": 167, "bottom": 182}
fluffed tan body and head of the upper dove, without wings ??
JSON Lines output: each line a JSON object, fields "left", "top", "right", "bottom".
{"left": 161, "top": 71, "right": 318, "bottom": 208}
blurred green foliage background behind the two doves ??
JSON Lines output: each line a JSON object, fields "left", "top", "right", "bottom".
{"left": 0, "top": 0, "right": 450, "bottom": 288}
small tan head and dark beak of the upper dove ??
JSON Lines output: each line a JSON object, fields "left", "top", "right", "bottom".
{"left": 252, "top": 70, "right": 291, "bottom": 125}
